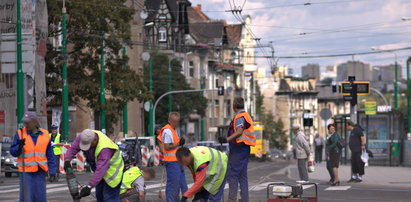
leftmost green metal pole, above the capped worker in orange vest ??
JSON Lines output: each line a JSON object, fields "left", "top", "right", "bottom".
{"left": 16, "top": 0, "right": 24, "bottom": 128}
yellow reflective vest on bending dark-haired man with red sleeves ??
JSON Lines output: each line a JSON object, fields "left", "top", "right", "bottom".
{"left": 190, "top": 146, "right": 228, "bottom": 195}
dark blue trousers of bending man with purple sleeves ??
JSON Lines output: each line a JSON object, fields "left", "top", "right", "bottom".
{"left": 96, "top": 180, "right": 121, "bottom": 202}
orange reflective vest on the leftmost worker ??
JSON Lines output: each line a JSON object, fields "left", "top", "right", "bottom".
{"left": 17, "top": 128, "right": 50, "bottom": 172}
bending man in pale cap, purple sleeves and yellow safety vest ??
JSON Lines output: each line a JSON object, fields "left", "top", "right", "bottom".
{"left": 64, "top": 129, "right": 124, "bottom": 202}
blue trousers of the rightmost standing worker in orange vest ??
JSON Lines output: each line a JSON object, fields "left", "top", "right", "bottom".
{"left": 227, "top": 146, "right": 250, "bottom": 202}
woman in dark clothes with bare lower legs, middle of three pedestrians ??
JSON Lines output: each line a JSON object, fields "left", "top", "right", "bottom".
{"left": 326, "top": 124, "right": 341, "bottom": 186}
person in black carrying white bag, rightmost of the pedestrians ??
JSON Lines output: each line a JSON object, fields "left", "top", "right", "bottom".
{"left": 347, "top": 121, "right": 365, "bottom": 182}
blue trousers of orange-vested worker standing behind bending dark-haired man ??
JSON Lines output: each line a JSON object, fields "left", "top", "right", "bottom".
{"left": 166, "top": 162, "right": 188, "bottom": 202}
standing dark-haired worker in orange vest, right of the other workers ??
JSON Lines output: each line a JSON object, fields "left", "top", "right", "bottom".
{"left": 218, "top": 97, "right": 256, "bottom": 202}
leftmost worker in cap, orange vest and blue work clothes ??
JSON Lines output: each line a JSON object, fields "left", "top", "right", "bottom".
{"left": 10, "top": 112, "right": 56, "bottom": 202}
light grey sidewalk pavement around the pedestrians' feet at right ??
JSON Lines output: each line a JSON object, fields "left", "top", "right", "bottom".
{"left": 302, "top": 161, "right": 411, "bottom": 188}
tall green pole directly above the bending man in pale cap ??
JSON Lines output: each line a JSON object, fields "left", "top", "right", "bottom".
{"left": 61, "top": 4, "right": 69, "bottom": 141}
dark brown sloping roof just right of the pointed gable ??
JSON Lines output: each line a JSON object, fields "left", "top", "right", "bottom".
{"left": 190, "top": 21, "right": 224, "bottom": 44}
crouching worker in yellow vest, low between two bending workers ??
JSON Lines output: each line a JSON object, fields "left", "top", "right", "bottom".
{"left": 120, "top": 166, "right": 155, "bottom": 202}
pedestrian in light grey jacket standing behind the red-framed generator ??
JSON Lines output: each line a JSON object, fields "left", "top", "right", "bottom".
{"left": 293, "top": 124, "right": 310, "bottom": 183}
